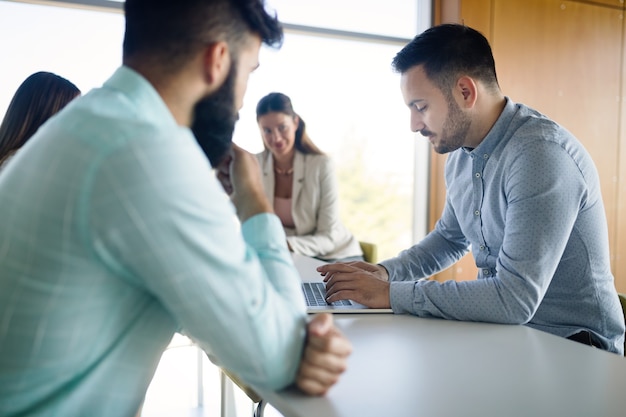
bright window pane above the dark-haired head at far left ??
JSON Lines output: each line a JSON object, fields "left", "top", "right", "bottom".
{"left": 0, "top": 1, "right": 124, "bottom": 111}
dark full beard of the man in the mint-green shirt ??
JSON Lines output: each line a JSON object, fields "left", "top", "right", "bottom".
{"left": 191, "top": 61, "right": 239, "bottom": 167}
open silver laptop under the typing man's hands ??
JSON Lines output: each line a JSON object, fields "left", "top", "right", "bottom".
{"left": 293, "top": 254, "right": 393, "bottom": 314}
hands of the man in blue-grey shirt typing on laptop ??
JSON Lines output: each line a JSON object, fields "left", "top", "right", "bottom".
{"left": 317, "top": 262, "right": 391, "bottom": 308}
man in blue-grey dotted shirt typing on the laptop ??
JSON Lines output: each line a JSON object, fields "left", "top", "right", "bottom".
{"left": 319, "top": 25, "right": 624, "bottom": 354}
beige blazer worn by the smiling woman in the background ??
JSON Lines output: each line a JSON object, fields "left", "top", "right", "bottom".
{"left": 256, "top": 150, "right": 363, "bottom": 260}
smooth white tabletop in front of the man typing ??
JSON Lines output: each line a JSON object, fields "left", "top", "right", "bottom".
{"left": 251, "top": 252, "right": 626, "bottom": 417}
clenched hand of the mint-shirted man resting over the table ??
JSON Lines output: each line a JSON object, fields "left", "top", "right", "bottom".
{"left": 296, "top": 313, "right": 352, "bottom": 395}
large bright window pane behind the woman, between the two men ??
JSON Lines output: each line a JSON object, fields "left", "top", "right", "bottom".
{"left": 234, "top": 33, "right": 422, "bottom": 259}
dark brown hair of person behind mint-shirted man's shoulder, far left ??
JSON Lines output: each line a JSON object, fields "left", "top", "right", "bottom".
{"left": 0, "top": 71, "right": 81, "bottom": 168}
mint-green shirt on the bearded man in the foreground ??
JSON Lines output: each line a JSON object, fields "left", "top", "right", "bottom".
{"left": 0, "top": 67, "right": 306, "bottom": 417}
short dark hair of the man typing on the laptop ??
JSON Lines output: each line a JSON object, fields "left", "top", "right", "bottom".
{"left": 392, "top": 24, "right": 498, "bottom": 91}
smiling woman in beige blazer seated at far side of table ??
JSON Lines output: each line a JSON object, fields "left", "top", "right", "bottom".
{"left": 256, "top": 93, "right": 363, "bottom": 261}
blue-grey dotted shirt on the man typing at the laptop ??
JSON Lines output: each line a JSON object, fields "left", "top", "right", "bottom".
{"left": 381, "top": 99, "right": 624, "bottom": 353}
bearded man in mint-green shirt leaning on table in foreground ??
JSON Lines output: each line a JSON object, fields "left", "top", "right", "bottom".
{"left": 0, "top": 0, "right": 350, "bottom": 417}
